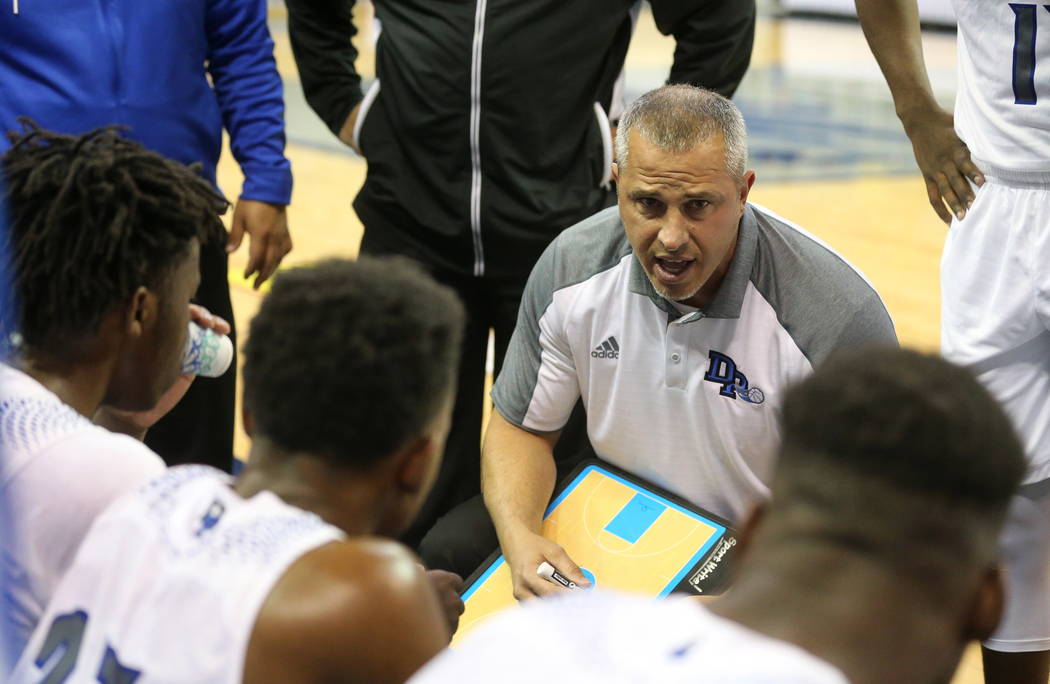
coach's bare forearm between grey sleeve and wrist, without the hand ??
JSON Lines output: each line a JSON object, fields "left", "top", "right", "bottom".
{"left": 481, "top": 411, "right": 558, "bottom": 543}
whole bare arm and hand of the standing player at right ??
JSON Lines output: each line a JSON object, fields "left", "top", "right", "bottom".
{"left": 856, "top": 0, "right": 984, "bottom": 223}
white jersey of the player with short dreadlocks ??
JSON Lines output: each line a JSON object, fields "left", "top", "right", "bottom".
{"left": 0, "top": 364, "right": 164, "bottom": 664}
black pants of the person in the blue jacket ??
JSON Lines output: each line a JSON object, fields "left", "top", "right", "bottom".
{"left": 146, "top": 241, "right": 237, "bottom": 472}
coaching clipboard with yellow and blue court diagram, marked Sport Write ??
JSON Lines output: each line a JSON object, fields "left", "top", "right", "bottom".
{"left": 453, "top": 459, "right": 736, "bottom": 647}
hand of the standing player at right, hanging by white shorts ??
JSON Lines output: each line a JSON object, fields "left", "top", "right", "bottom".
{"left": 901, "top": 108, "right": 984, "bottom": 224}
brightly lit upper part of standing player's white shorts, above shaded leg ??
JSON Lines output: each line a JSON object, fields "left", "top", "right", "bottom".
{"left": 941, "top": 178, "right": 1050, "bottom": 482}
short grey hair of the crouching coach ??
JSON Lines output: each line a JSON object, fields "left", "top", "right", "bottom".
{"left": 616, "top": 85, "right": 748, "bottom": 179}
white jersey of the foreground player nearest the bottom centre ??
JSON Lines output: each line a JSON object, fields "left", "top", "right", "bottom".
{"left": 410, "top": 590, "right": 847, "bottom": 684}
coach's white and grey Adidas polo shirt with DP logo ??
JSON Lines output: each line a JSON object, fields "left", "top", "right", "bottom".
{"left": 492, "top": 204, "right": 897, "bottom": 519}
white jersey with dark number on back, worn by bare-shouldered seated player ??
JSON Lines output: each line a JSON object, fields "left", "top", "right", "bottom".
{"left": 11, "top": 465, "right": 343, "bottom": 684}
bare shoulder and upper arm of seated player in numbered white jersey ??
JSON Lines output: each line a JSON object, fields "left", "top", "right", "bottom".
{"left": 244, "top": 540, "right": 449, "bottom": 684}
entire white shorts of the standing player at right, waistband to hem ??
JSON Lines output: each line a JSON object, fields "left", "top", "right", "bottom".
{"left": 941, "top": 178, "right": 1050, "bottom": 651}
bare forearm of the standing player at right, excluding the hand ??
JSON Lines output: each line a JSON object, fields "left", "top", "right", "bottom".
{"left": 856, "top": 0, "right": 940, "bottom": 129}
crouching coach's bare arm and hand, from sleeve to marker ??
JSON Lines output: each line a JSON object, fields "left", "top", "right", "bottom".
{"left": 481, "top": 411, "right": 587, "bottom": 600}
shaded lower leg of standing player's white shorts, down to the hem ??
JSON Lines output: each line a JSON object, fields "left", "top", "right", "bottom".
{"left": 984, "top": 480, "right": 1050, "bottom": 652}
